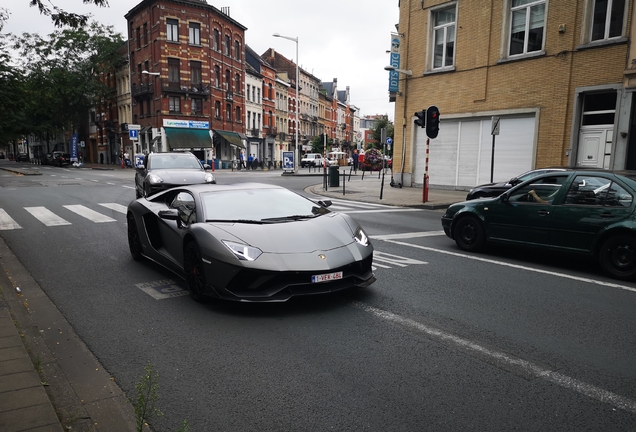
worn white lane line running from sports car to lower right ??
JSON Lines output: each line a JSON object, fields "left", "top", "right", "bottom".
{"left": 352, "top": 302, "right": 636, "bottom": 413}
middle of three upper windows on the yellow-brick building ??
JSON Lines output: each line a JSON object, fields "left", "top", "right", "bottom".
{"left": 508, "top": 0, "right": 545, "bottom": 56}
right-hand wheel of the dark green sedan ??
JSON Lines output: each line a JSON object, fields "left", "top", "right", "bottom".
{"left": 599, "top": 234, "right": 636, "bottom": 280}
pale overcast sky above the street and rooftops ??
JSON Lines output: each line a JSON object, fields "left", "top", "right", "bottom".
{"left": 2, "top": 0, "right": 399, "bottom": 120}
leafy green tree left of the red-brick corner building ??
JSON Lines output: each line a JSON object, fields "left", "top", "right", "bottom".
{"left": 0, "top": 23, "right": 124, "bottom": 143}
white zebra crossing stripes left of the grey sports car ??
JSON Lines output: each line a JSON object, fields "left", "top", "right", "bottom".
{"left": 0, "top": 203, "right": 127, "bottom": 231}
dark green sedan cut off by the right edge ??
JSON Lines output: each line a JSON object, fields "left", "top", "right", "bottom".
{"left": 442, "top": 170, "right": 636, "bottom": 280}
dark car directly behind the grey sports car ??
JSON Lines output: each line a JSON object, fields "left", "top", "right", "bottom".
{"left": 135, "top": 152, "right": 216, "bottom": 198}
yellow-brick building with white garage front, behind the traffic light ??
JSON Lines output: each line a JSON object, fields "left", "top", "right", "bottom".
{"left": 391, "top": 0, "right": 636, "bottom": 189}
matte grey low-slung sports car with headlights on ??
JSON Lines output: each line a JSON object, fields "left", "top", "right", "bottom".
{"left": 127, "top": 182, "right": 376, "bottom": 302}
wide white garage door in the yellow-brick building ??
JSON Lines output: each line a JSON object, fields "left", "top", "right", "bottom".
{"left": 413, "top": 116, "right": 535, "bottom": 188}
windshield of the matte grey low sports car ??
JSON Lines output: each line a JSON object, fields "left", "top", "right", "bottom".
{"left": 201, "top": 189, "right": 329, "bottom": 222}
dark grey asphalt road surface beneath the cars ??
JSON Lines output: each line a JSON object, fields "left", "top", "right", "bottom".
{"left": 0, "top": 161, "right": 636, "bottom": 431}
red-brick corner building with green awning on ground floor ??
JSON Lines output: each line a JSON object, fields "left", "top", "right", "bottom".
{"left": 125, "top": 0, "right": 246, "bottom": 166}
